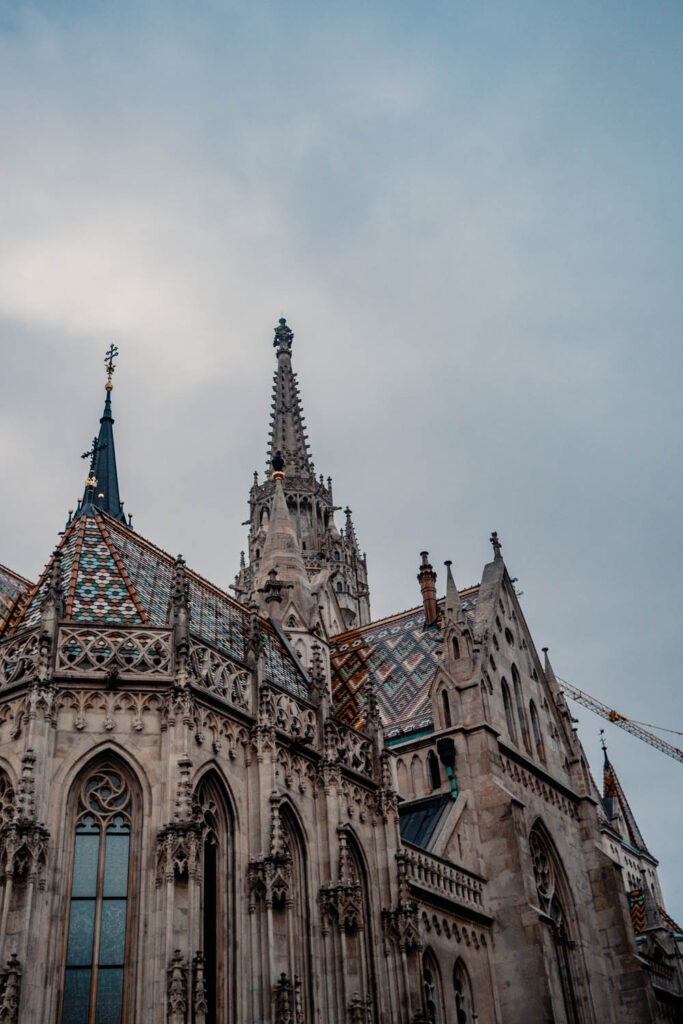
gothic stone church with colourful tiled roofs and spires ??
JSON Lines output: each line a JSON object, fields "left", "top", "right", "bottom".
{"left": 0, "top": 319, "right": 683, "bottom": 1024}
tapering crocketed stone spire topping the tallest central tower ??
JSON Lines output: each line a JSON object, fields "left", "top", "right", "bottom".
{"left": 267, "top": 316, "right": 313, "bottom": 475}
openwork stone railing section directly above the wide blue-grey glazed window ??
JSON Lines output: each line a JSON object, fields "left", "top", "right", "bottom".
{"left": 55, "top": 625, "right": 172, "bottom": 678}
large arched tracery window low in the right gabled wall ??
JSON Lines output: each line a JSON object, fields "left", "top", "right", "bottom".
{"left": 528, "top": 822, "right": 580, "bottom": 1024}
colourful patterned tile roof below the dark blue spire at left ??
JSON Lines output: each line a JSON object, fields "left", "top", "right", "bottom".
{"left": 6, "top": 510, "right": 307, "bottom": 695}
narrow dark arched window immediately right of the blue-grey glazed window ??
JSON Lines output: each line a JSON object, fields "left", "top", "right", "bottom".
{"left": 194, "top": 773, "right": 232, "bottom": 1024}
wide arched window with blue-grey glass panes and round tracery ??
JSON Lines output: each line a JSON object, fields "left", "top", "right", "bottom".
{"left": 61, "top": 762, "right": 139, "bottom": 1024}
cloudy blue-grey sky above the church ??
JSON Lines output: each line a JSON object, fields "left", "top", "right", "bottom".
{"left": 0, "top": 0, "right": 683, "bottom": 922}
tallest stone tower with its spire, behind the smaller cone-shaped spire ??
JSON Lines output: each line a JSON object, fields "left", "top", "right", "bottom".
{"left": 233, "top": 317, "right": 370, "bottom": 636}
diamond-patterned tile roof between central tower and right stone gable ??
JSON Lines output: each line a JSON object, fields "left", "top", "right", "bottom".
{"left": 330, "top": 587, "right": 479, "bottom": 739}
